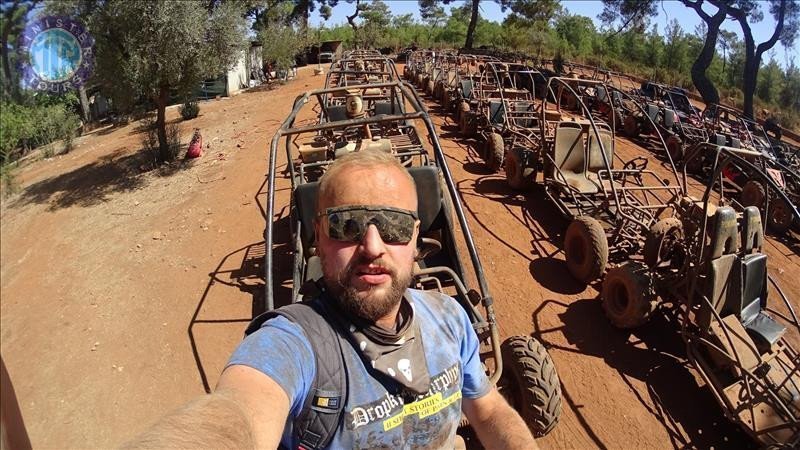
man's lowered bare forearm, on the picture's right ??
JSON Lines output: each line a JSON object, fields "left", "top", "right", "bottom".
{"left": 461, "top": 388, "right": 539, "bottom": 450}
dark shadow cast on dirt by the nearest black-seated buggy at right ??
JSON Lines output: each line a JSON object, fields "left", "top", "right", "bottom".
{"left": 532, "top": 299, "right": 752, "bottom": 448}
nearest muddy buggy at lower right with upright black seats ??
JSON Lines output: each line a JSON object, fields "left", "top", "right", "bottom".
{"left": 601, "top": 147, "right": 800, "bottom": 448}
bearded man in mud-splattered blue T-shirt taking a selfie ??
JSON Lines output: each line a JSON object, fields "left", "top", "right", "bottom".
{"left": 125, "top": 151, "right": 536, "bottom": 449}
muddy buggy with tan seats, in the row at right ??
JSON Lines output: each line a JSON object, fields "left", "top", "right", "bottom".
{"left": 504, "top": 77, "right": 685, "bottom": 283}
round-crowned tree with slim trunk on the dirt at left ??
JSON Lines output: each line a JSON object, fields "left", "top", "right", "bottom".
{"left": 90, "top": 0, "right": 247, "bottom": 160}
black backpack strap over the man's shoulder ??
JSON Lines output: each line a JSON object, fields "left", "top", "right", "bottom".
{"left": 245, "top": 300, "right": 347, "bottom": 450}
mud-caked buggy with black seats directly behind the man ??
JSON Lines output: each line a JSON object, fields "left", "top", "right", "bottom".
{"left": 264, "top": 82, "right": 561, "bottom": 436}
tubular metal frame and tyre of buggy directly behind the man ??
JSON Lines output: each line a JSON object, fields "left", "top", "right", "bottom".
{"left": 264, "top": 82, "right": 561, "bottom": 436}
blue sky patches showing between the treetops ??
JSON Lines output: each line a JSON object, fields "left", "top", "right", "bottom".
{"left": 311, "top": 0, "right": 800, "bottom": 66}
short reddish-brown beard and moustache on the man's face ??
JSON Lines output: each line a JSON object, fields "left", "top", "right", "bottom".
{"left": 320, "top": 255, "right": 411, "bottom": 323}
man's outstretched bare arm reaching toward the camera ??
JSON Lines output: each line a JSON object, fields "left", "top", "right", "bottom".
{"left": 124, "top": 365, "right": 289, "bottom": 449}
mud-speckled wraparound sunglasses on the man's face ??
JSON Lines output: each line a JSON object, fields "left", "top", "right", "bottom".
{"left": 317, "top": 205, "right": 418, "bottom": 244}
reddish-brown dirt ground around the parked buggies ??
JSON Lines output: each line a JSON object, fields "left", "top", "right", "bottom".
{"left": 0, "top": 68, "right": 800, "bottom": 448}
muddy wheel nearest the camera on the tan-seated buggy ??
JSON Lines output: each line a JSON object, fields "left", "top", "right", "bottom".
{"left": 564, "top": 216, "right": 608, "bottom": 284}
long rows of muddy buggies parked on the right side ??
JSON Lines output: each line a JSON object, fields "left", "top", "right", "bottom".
{"left": 404, "top": 46, "right": 800, "bottom": 448}
